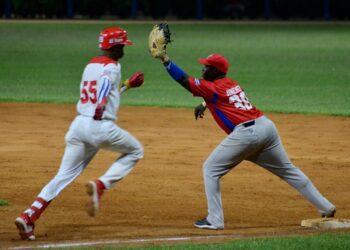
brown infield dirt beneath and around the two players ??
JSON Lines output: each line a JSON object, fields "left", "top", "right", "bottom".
{"left": 0, "top": 103, "right": 350, "bottom": 247}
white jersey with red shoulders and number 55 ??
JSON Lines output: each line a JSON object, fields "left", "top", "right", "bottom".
{"left": 77, "top": 56, "right": 121, "bottom": 120}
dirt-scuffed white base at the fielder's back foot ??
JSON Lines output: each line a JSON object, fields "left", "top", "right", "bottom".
{"left": 301, "top": 218, "right": 350, "bottom": 229}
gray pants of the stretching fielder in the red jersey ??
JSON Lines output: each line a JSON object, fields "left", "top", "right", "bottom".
{"left": 203, "top": 116, "right": 335, "bottom": 229}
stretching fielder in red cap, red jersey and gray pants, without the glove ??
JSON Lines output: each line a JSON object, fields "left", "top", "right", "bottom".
{"left": 155, "top": 53, "right": 336, "bottom": 229}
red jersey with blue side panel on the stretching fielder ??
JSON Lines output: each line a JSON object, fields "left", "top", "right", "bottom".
{"left": 189, "top": 77, "right": 263, "bottom": 134}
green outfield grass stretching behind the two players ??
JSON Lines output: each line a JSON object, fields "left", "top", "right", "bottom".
{"left": 0, "top": 22, "right": 350, "bottom": 116}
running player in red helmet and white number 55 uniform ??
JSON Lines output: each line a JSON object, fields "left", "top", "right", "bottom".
{"left": 15, "top": 27, "right": 143, "bottom": 240}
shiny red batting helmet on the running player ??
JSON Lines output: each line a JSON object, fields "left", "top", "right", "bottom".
{"left": 98, "top": 27, "right": 133, "bottom": 50}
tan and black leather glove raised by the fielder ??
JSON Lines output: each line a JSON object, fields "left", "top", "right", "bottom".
{"left": 148, "top": 23, "right": 171, "bottom": 62}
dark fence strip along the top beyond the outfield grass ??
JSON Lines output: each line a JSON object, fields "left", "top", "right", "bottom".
{"left": 0, "top": 0, "right": 350, "bottom": 20}
